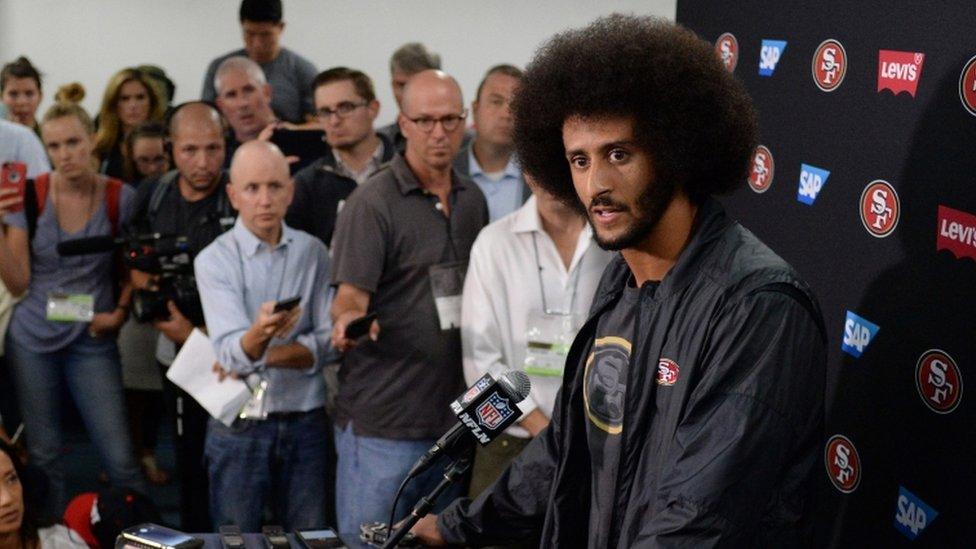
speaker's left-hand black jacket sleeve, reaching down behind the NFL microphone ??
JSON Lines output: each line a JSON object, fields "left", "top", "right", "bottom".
{"left": 437, "top": 390, "right": 563, "bottom": 545}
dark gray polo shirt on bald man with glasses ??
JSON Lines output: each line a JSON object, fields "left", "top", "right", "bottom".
{"left": 331, "top": 155, "right": 488, "bottom": 440}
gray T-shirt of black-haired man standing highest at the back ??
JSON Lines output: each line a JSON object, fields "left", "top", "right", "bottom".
{"left": 200, "top": 48, "right": 317, "bottom": 123}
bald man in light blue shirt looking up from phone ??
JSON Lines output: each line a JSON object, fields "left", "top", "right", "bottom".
{"left": 194, "top": 141, "right": 333, "bottom": 532}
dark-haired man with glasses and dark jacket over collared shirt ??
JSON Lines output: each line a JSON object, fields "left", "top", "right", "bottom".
{"left": 286, "top": 67, "right": 395, "bottom": 246}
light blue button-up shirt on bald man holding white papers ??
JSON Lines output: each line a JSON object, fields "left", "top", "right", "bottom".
{"left": 193, "top": 218, "right": 332, "bottom": 412}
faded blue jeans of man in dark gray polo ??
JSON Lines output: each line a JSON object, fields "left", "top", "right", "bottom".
{"left": 335, "top": 421, "right": 467, "bottom": 532}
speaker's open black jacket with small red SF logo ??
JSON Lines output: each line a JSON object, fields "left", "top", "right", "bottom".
{"left": 438, "top": 200, "right": 826, "bottom": 547}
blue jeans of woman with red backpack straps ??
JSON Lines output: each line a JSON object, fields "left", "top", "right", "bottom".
{"left": 6, "top": 334, "right": 146, "bottom": 517}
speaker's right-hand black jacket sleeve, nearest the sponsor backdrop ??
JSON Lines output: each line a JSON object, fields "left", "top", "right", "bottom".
{"left": 633, "top": 287, "right": 826, "bottom": 547}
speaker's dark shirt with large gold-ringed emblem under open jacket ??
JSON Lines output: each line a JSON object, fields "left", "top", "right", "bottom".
{"left": 583, "top": 278, "right": 658, "bottom": 547}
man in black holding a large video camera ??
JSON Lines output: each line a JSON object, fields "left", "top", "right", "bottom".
{"left": 132, "top": 102, "right": 236, "bottom": 532}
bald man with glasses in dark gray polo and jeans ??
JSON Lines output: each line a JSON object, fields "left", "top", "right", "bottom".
{"left": 332, "top": 70, "right": 488, "bottom": 532}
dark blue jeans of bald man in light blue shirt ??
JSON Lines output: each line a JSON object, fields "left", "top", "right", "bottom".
{"left": 204, "top": 408, "right": 332, "bottom": 532}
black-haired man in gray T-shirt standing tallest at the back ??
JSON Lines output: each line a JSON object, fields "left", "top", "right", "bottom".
{"left": 200, "top": 0, "right": 318, "bottom": 123}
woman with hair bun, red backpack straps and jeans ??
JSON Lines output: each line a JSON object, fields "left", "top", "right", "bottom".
{"left": 0, "top": 103, "right": 142, "bottom": 514}
